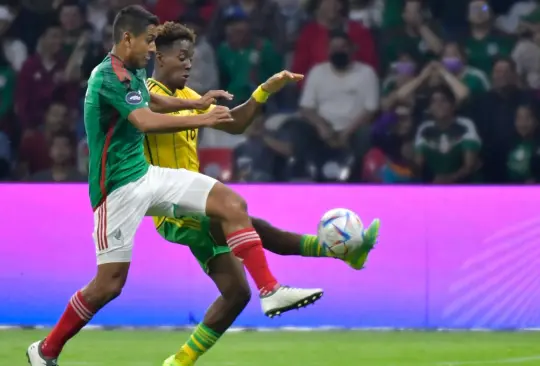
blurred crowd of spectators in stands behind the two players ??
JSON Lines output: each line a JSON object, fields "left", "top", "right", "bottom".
{"left": 0, "top": 0, "right": 540, "bottom": 184}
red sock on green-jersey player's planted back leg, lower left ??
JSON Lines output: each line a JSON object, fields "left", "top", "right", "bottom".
{"left": 41, "top": 291, "right": 95, "bottom": 358}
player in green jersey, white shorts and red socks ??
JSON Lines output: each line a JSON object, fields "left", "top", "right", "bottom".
{"left": 27, "top": 6, "right": 322, "bottom": 366}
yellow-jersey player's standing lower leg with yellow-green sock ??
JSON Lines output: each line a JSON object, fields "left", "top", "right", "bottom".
{"left": 163, "top": 253, "right": 251, "bottom": 366}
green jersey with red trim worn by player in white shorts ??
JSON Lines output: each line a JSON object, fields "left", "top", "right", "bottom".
{"left": 84, "top": 55, "right": 150, "bottom": 209}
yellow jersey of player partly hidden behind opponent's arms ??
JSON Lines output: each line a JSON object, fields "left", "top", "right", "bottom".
{"left": 144, "top": 78, "right": 212, "bottom": 172}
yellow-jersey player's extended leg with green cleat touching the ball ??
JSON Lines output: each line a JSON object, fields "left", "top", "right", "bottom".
{"left": 238, "top": 218, "right": 380, "bottom": 269}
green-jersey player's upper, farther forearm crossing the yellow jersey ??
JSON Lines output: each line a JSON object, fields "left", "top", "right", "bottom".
{"left": 150, "top": 90, "right": 232, "bottom": 113}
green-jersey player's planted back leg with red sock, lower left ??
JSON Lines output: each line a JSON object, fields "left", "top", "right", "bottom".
{"left": 26, "top": 263, "right": 129, "bottom": 366}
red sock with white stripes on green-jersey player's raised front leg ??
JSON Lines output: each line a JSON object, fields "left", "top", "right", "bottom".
{"left": 227, "top": 227, "right": 278, "bottom": 293}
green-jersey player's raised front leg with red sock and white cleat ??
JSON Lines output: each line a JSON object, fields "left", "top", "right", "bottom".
{"left": 202, "top": 183, "right": 323, "bottom": 317}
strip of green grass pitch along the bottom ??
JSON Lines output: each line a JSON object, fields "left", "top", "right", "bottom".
{"left": 0, "top": 330, "right": 540, "bottom": 366}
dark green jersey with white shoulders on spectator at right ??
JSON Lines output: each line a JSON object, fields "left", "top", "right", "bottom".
{"left": 415, "top": 117, "right": 481, "bottom": 180}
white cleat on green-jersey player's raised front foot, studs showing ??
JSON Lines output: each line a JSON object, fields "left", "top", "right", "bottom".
{"left": 261, "top": 286, "right": 324, "bottom": 318}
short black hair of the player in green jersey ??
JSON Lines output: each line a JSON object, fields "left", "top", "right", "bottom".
{"left": 113, "top": 5, "right": 159, "bottom": 43}
